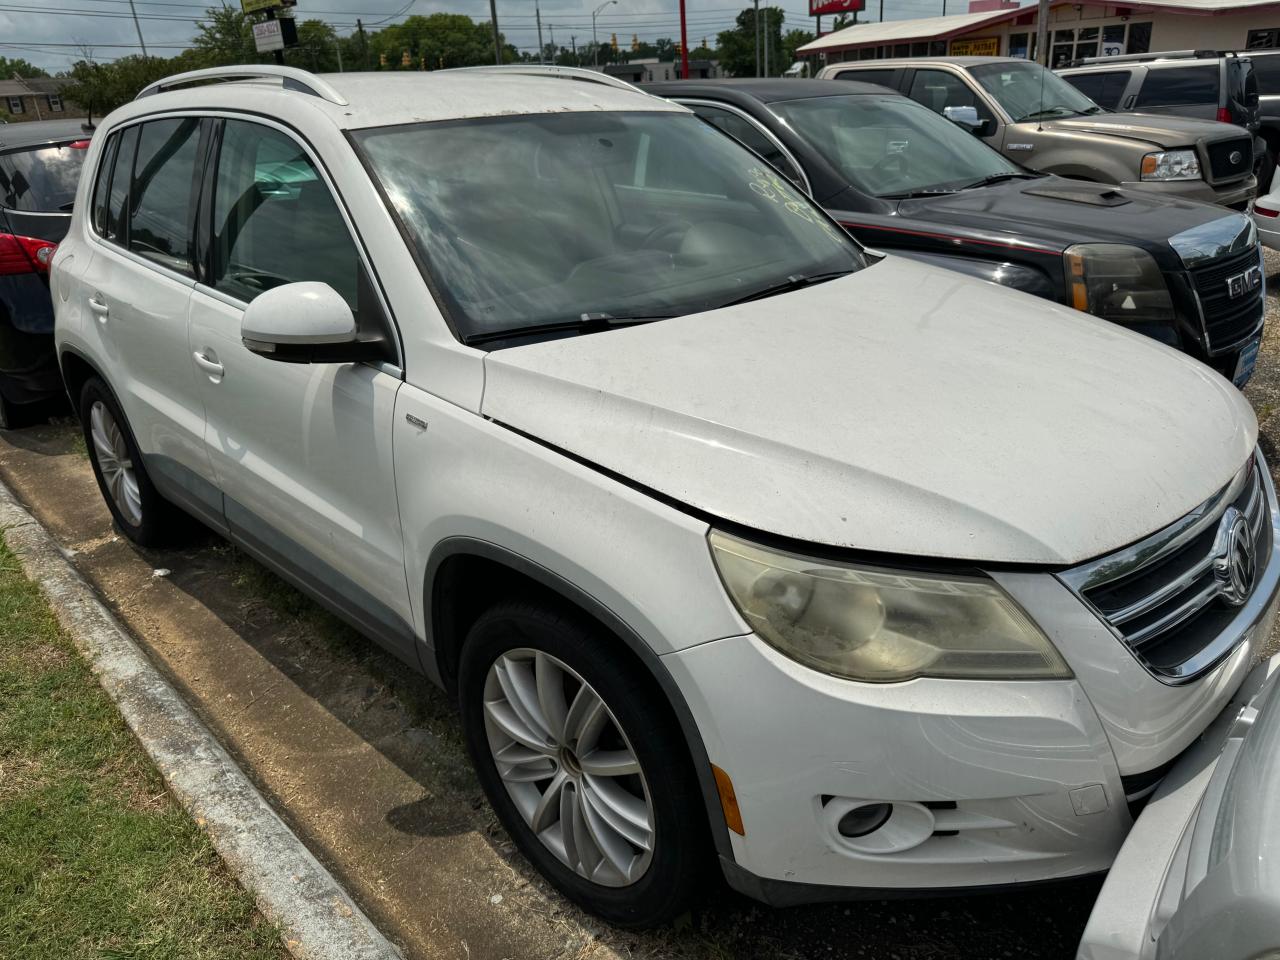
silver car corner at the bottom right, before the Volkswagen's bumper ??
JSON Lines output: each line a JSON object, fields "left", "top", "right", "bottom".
{"left": 1079, "top": 663, "right": 1280, "bottom": 960}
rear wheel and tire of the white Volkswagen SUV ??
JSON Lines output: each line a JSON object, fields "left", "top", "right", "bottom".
{"left": 79, "top": 376, "right": 191, "bottom": 547}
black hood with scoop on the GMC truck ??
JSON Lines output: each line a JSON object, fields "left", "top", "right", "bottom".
{"left": 897, "top": 177, "right": 1226, "bottom": 251}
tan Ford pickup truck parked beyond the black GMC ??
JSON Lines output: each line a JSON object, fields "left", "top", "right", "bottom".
{"left": 818, "top": 56, "right": 1257, "bottom": 211}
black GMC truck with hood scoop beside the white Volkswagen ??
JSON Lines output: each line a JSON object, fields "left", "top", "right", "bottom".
{"left": 645, "top": 79, "right": 1263, "bottom": 385}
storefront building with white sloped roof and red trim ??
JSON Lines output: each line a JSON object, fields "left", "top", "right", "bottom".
{"left": 797, "top": 0, "right": 1280, "bottom": 67}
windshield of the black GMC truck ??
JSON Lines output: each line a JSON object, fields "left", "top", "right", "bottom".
{"left": 771, "top": 95, "right": 1023, "bottom": 197}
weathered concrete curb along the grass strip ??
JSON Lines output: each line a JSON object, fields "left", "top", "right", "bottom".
{"left": 0, "top": 481, "right": 402, "bottom": 960}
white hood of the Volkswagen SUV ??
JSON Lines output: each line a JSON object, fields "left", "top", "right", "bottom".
{"left": 481, "top": 257, "right": 1257, "bottom": 564}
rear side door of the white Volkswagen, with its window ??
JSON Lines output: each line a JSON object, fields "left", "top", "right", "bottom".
{"left": 76, "top": 116, "right": 213, "bottom": 524}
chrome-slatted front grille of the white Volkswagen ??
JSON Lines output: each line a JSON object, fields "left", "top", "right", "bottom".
{"left": 1059, "top": 456, "right": 1275, "bottom": 682}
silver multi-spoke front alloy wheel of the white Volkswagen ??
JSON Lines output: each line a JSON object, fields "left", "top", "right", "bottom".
{"left": 484, "top": 649, "right": 655, "bottom": 887}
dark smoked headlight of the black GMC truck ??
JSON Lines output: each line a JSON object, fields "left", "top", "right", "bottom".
{"left": 1064, "top": 243, "right": 1174, "bottom": 324}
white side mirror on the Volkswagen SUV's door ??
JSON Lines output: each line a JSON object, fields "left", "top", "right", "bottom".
{"left": 241, "top": 280, "right": 376, "bottom": 364}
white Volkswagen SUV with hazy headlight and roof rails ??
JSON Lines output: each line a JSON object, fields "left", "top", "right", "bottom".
{"left": 52, "top": 68, "right": 1280, "bottom": 942}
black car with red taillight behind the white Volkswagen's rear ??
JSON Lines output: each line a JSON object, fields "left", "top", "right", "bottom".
{"left": 0, "top": 120, "right": 91, "bottom": 429}
